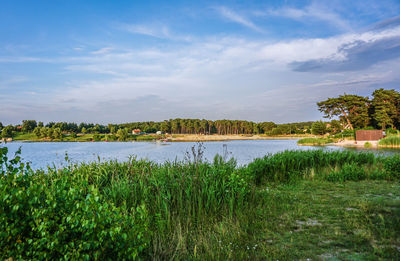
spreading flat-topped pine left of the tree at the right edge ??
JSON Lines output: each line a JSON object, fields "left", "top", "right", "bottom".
{"left": 317, "top": 94, "right": 370, "bottom": 130}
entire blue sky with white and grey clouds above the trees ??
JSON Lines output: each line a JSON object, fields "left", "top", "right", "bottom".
{"left": 0, "top": 0, "right": 400, "bottom": 124}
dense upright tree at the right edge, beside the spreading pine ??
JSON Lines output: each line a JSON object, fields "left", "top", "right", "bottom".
{"left": 372, "top": 89, "right": 400, "bottom": 129}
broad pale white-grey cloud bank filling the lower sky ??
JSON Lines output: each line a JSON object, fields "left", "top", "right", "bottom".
{"left": 0, "top": 11, "right": 400, "bottom": 123}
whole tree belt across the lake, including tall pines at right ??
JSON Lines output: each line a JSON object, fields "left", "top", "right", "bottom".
{"left": 0, "top": 89, "right": 400, "bottom": 139}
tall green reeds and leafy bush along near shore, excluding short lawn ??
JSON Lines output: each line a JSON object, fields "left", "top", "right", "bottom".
{"left": 0, "top": 148, "right": 400, "bottom": 259}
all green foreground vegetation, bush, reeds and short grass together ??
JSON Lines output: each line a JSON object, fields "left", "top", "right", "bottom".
{"left": 0, "top": 147, "right": 400, "bottom": 260}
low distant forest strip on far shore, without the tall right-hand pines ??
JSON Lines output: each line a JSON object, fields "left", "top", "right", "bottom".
{"left": 0, "top": 119, "right": 313, "bottom": 139}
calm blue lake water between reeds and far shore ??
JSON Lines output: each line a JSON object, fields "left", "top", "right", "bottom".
{"left": 0, "top": 140, "right": 400, "bottom": 169}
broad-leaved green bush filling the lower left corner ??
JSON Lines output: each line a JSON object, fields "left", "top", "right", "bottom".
{"left": 0, "top": 148, "right": 150, "bottom": 260}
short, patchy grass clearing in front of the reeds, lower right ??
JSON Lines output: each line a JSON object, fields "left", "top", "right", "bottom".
{"left": 206, "top": 181, "right": 400, "bottom": 260}
